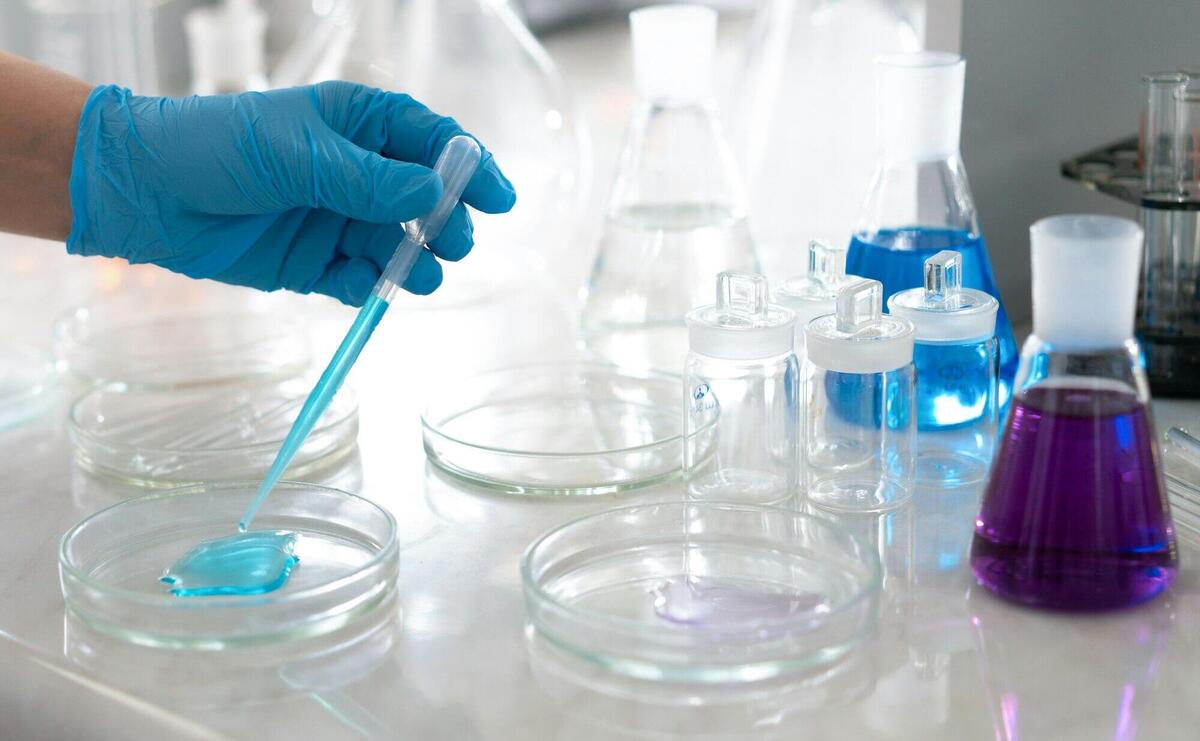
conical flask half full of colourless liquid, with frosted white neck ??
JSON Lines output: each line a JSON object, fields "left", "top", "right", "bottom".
{"left": 582, "top": 5, "right": 758, "bottom": 372}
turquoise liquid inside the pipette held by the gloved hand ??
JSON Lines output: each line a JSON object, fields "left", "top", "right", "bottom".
{"left": 238, "top": 293, "right": 388, "bottom": 532}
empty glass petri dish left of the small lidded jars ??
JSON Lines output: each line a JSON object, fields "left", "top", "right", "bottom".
{"left": 421, "top": 363, "right": 684, "bottom": 494}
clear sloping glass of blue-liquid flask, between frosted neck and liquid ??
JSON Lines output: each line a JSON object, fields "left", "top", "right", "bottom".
{"left": 857, "top": 152, "right": 979, "bottom": 238}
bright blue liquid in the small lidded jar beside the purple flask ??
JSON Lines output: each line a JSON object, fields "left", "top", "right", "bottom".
{"left": 912, "top": 342, "right": 995, "bottom": 430}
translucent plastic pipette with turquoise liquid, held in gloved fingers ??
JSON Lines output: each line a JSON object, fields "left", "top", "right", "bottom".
{"left": 238, "top": 135, "right": 481, "bottom": 531}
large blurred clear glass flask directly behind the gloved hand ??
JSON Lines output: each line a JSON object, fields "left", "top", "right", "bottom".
{"left": 271, "top": 0, "right": 592, "bottom": 303}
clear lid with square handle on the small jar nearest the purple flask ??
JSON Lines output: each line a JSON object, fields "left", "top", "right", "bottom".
{"left": 888, "top": 249, "right": 1000, "bottom": 342}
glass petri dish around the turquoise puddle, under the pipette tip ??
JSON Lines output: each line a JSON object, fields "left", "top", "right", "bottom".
{"left": 59, "top": 481, "right": 400, "bottom": 651}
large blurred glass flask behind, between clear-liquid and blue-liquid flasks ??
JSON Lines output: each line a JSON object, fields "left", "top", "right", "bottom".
{"left": 730, "top": 0, "right": 920, "bottom": 279}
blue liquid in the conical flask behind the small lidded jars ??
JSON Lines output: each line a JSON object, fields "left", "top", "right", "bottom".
{"left": 846, "top": 227, "right": 1020, "bottom": 411}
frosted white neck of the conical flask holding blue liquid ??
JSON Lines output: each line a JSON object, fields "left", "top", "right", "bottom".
{"left": 875, "top": 52, "right": 966, "bottom": 162}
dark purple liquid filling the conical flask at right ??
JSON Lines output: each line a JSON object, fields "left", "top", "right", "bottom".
{"left": 971, "top": 387, "right": 1176, "bottom": 610}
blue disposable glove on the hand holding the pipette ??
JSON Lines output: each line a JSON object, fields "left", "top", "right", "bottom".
{"left": 67, "top": 83, "right": 516, "bottom": 306}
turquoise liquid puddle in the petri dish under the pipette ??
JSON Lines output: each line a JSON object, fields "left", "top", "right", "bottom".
{"left": 160, "top": 530, "right": 300, "bottom": 597}
